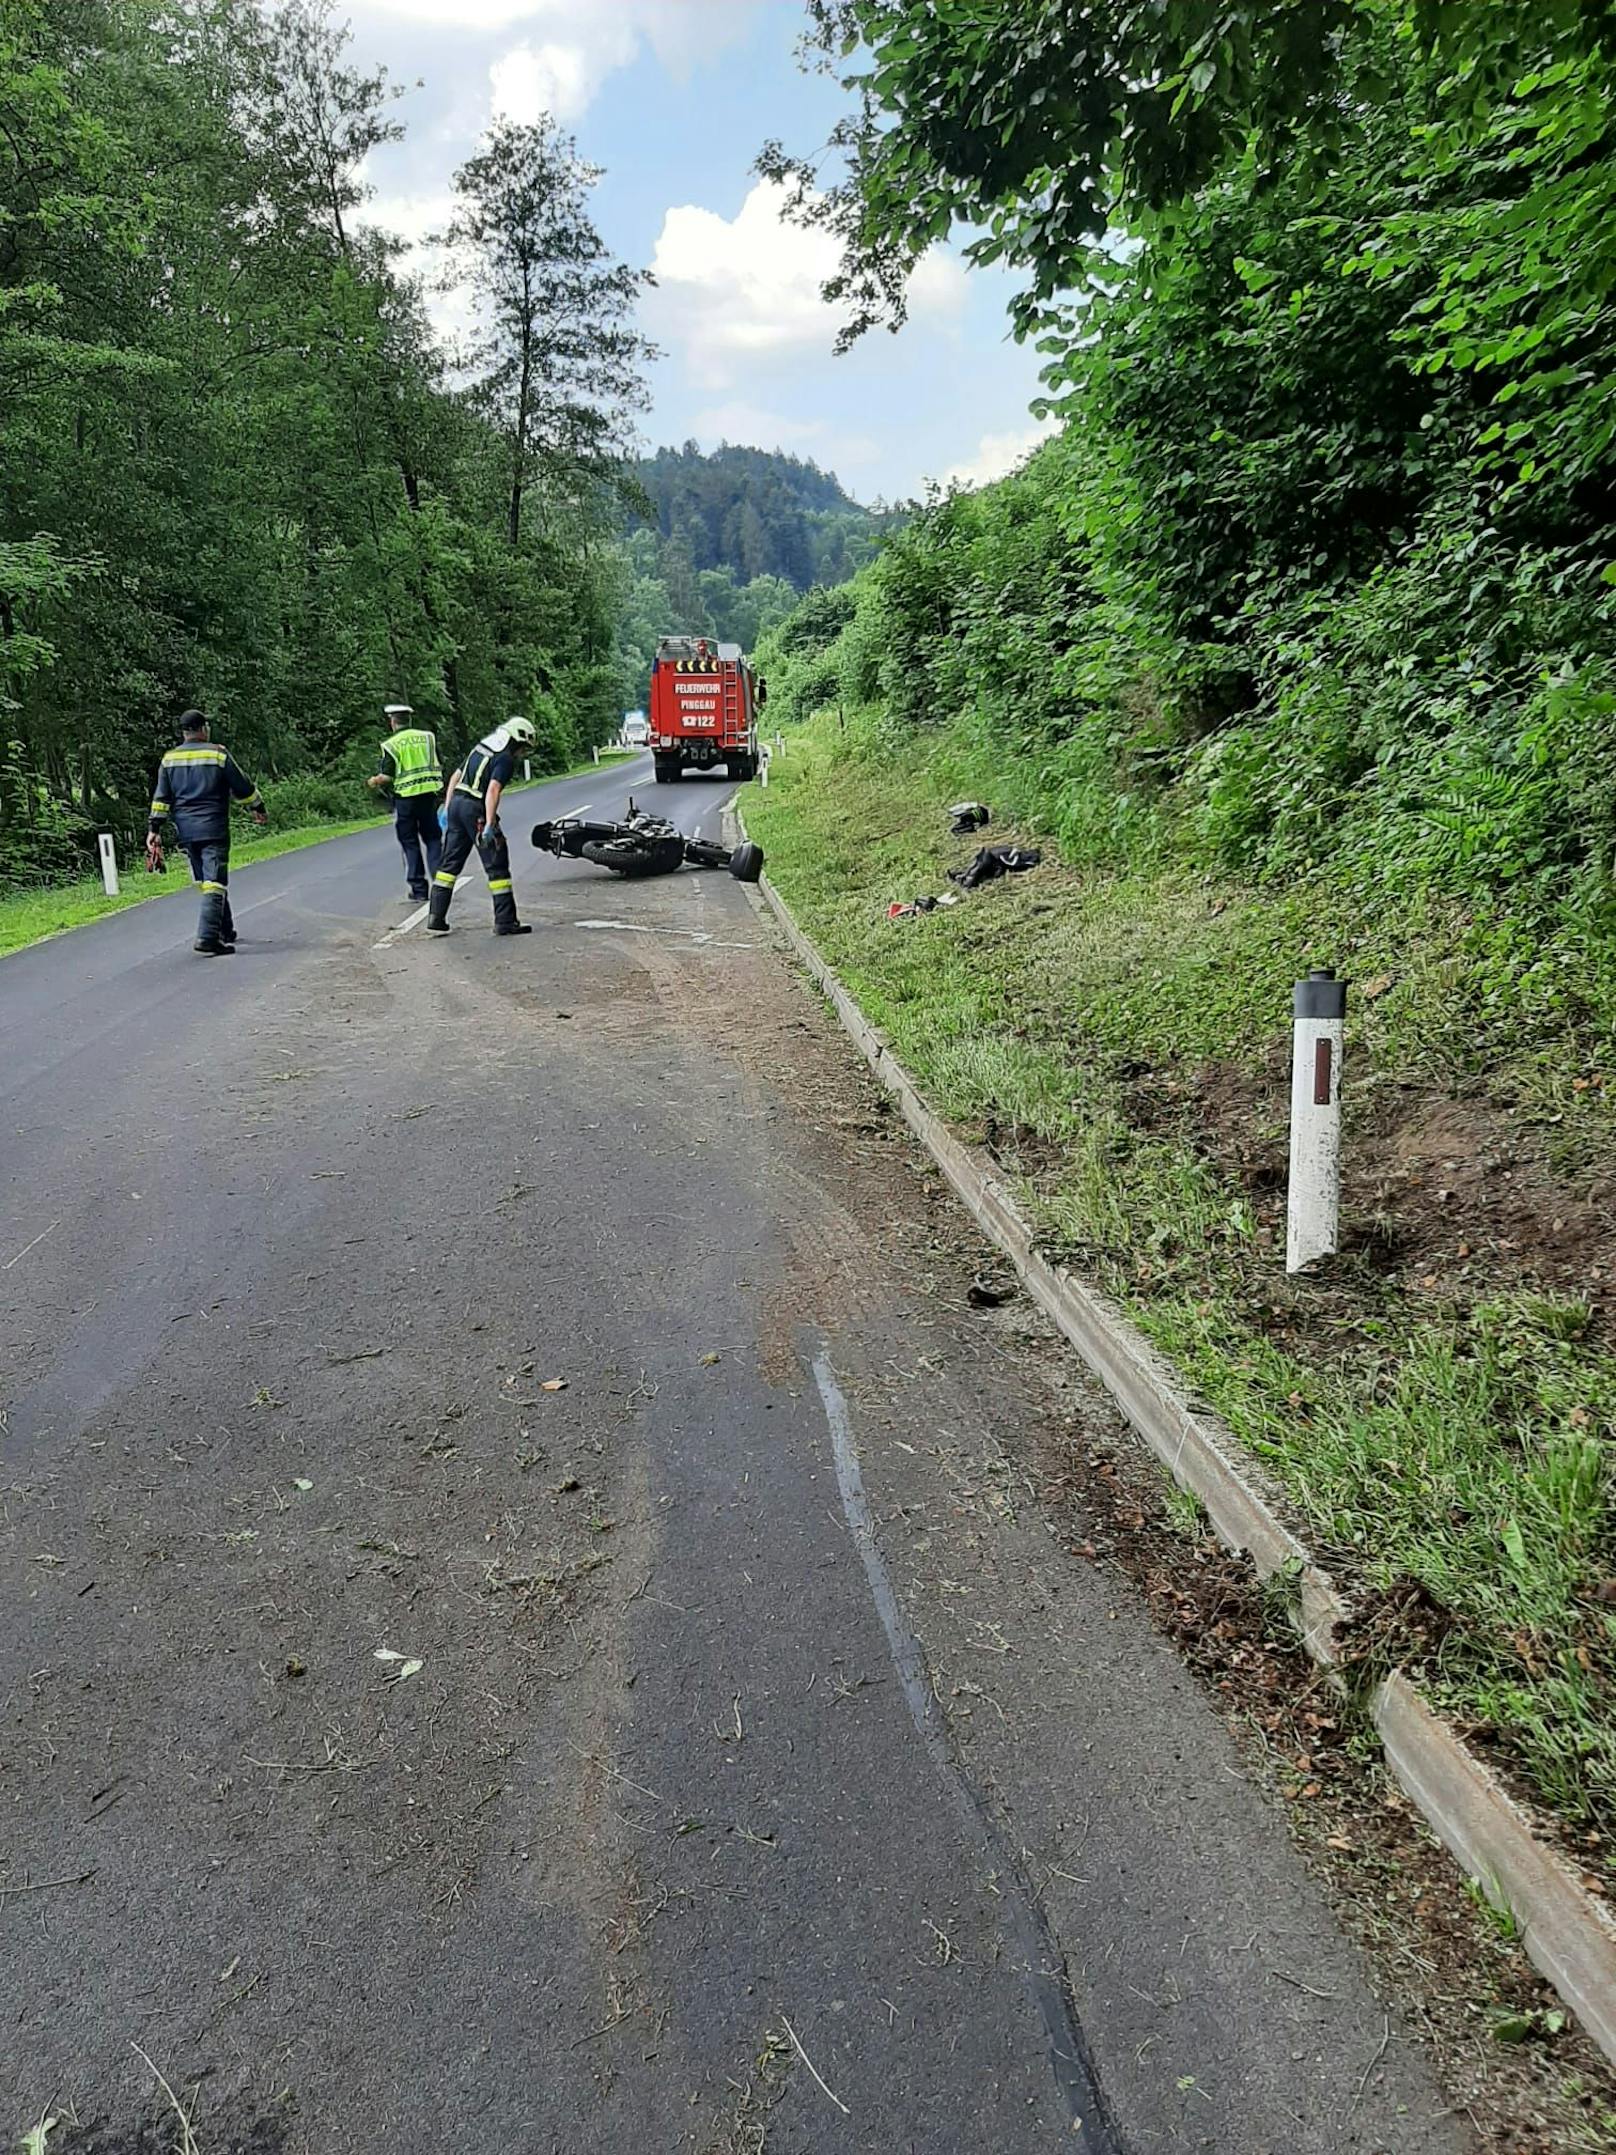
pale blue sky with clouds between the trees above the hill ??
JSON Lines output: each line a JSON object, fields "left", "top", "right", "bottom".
{"left": 336, "top": 0, "right": 1064, "bottom": 500}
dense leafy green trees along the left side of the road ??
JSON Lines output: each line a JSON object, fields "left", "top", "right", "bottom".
{"left": 0, "top": 0, "right": 655, "bottom": 881}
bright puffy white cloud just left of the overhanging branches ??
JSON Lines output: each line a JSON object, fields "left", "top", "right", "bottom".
{"left": 644, "top": 181, "right": 965, "bottom": 388}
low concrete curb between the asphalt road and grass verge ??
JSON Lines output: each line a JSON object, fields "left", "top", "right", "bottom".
{"left": 737, "top": 812, "right": 1616, "bottom": 2064}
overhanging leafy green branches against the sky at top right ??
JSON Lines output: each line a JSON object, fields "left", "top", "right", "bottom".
{"left": 758, "top": 0, "right": 1616, "bottom": 349}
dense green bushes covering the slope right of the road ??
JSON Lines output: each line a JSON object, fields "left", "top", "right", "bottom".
{"left": 774, "top": 4, "right": 1616, "bottom": 948}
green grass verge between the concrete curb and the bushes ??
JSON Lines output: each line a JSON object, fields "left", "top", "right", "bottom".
{"left": 746, "top": 722, "right": 1616, "bottom": 1862}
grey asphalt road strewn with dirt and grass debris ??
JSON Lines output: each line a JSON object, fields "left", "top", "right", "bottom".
{"left": 0, "top": 759, "right": 1467, "bottom": 2155}
